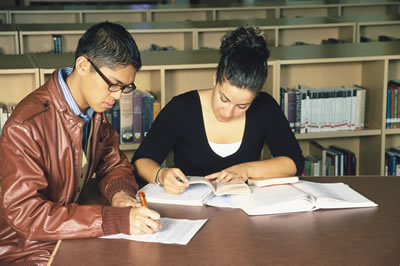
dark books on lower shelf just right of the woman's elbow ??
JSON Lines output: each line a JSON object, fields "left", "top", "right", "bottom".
{"left": 303, "top": 141, "right": 357, "bottom": 176}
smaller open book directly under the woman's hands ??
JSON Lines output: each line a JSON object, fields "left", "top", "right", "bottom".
{"left": 137, "top": 176, "right": 251, "bottom": 206}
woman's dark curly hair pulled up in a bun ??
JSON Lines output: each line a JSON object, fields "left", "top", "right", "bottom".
{"left": 217, "top": 27, "right": 269, "bottom": 92}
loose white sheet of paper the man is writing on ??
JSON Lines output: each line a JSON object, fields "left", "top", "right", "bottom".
{"left": 100, "top": 218, "right": 207, "bottom": 245}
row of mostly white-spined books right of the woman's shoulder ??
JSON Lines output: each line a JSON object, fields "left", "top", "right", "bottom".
{"left": 280, "top": 85, "right": 366, "bottom": 133}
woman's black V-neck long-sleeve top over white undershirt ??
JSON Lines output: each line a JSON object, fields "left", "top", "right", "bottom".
{"left": 132, "top": 91, "right": 304, "bottom": 176}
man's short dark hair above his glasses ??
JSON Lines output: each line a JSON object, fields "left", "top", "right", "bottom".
{"left": 75, "top": 22, "right": 142, "bottom": 70}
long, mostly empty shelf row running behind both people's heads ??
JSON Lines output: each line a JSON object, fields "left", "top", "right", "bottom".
{"left": 14, "top": 17, "right": 357, "bottom": 54}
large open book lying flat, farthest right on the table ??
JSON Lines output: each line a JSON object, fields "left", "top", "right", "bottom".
{"left": 207, "top": 181, "right": 378, "bottom": 215}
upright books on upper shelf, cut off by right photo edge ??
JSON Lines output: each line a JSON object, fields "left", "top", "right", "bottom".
{"left": 386, "top": 80, "right": 400, "bottom": 128}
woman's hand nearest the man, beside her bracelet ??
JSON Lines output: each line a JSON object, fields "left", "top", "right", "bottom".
{"left": 158, "top": 168, "right": 189, "bottom": 194}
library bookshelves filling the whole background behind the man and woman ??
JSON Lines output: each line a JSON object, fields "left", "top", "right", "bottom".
{"left": 0, "top": 0, "right": 400, "bottom": 176}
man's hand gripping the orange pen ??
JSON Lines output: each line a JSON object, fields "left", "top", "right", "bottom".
{"left": 129, "top": 207, "right": 161, "bottom": 235}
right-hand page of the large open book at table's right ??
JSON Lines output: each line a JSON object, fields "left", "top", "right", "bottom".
{"left": 294, "top": 181, "right": 378, "bottom": 209}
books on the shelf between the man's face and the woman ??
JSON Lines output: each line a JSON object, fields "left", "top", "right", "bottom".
{"left": 106, "top": 90, "right": 161, "bottom": 144}
